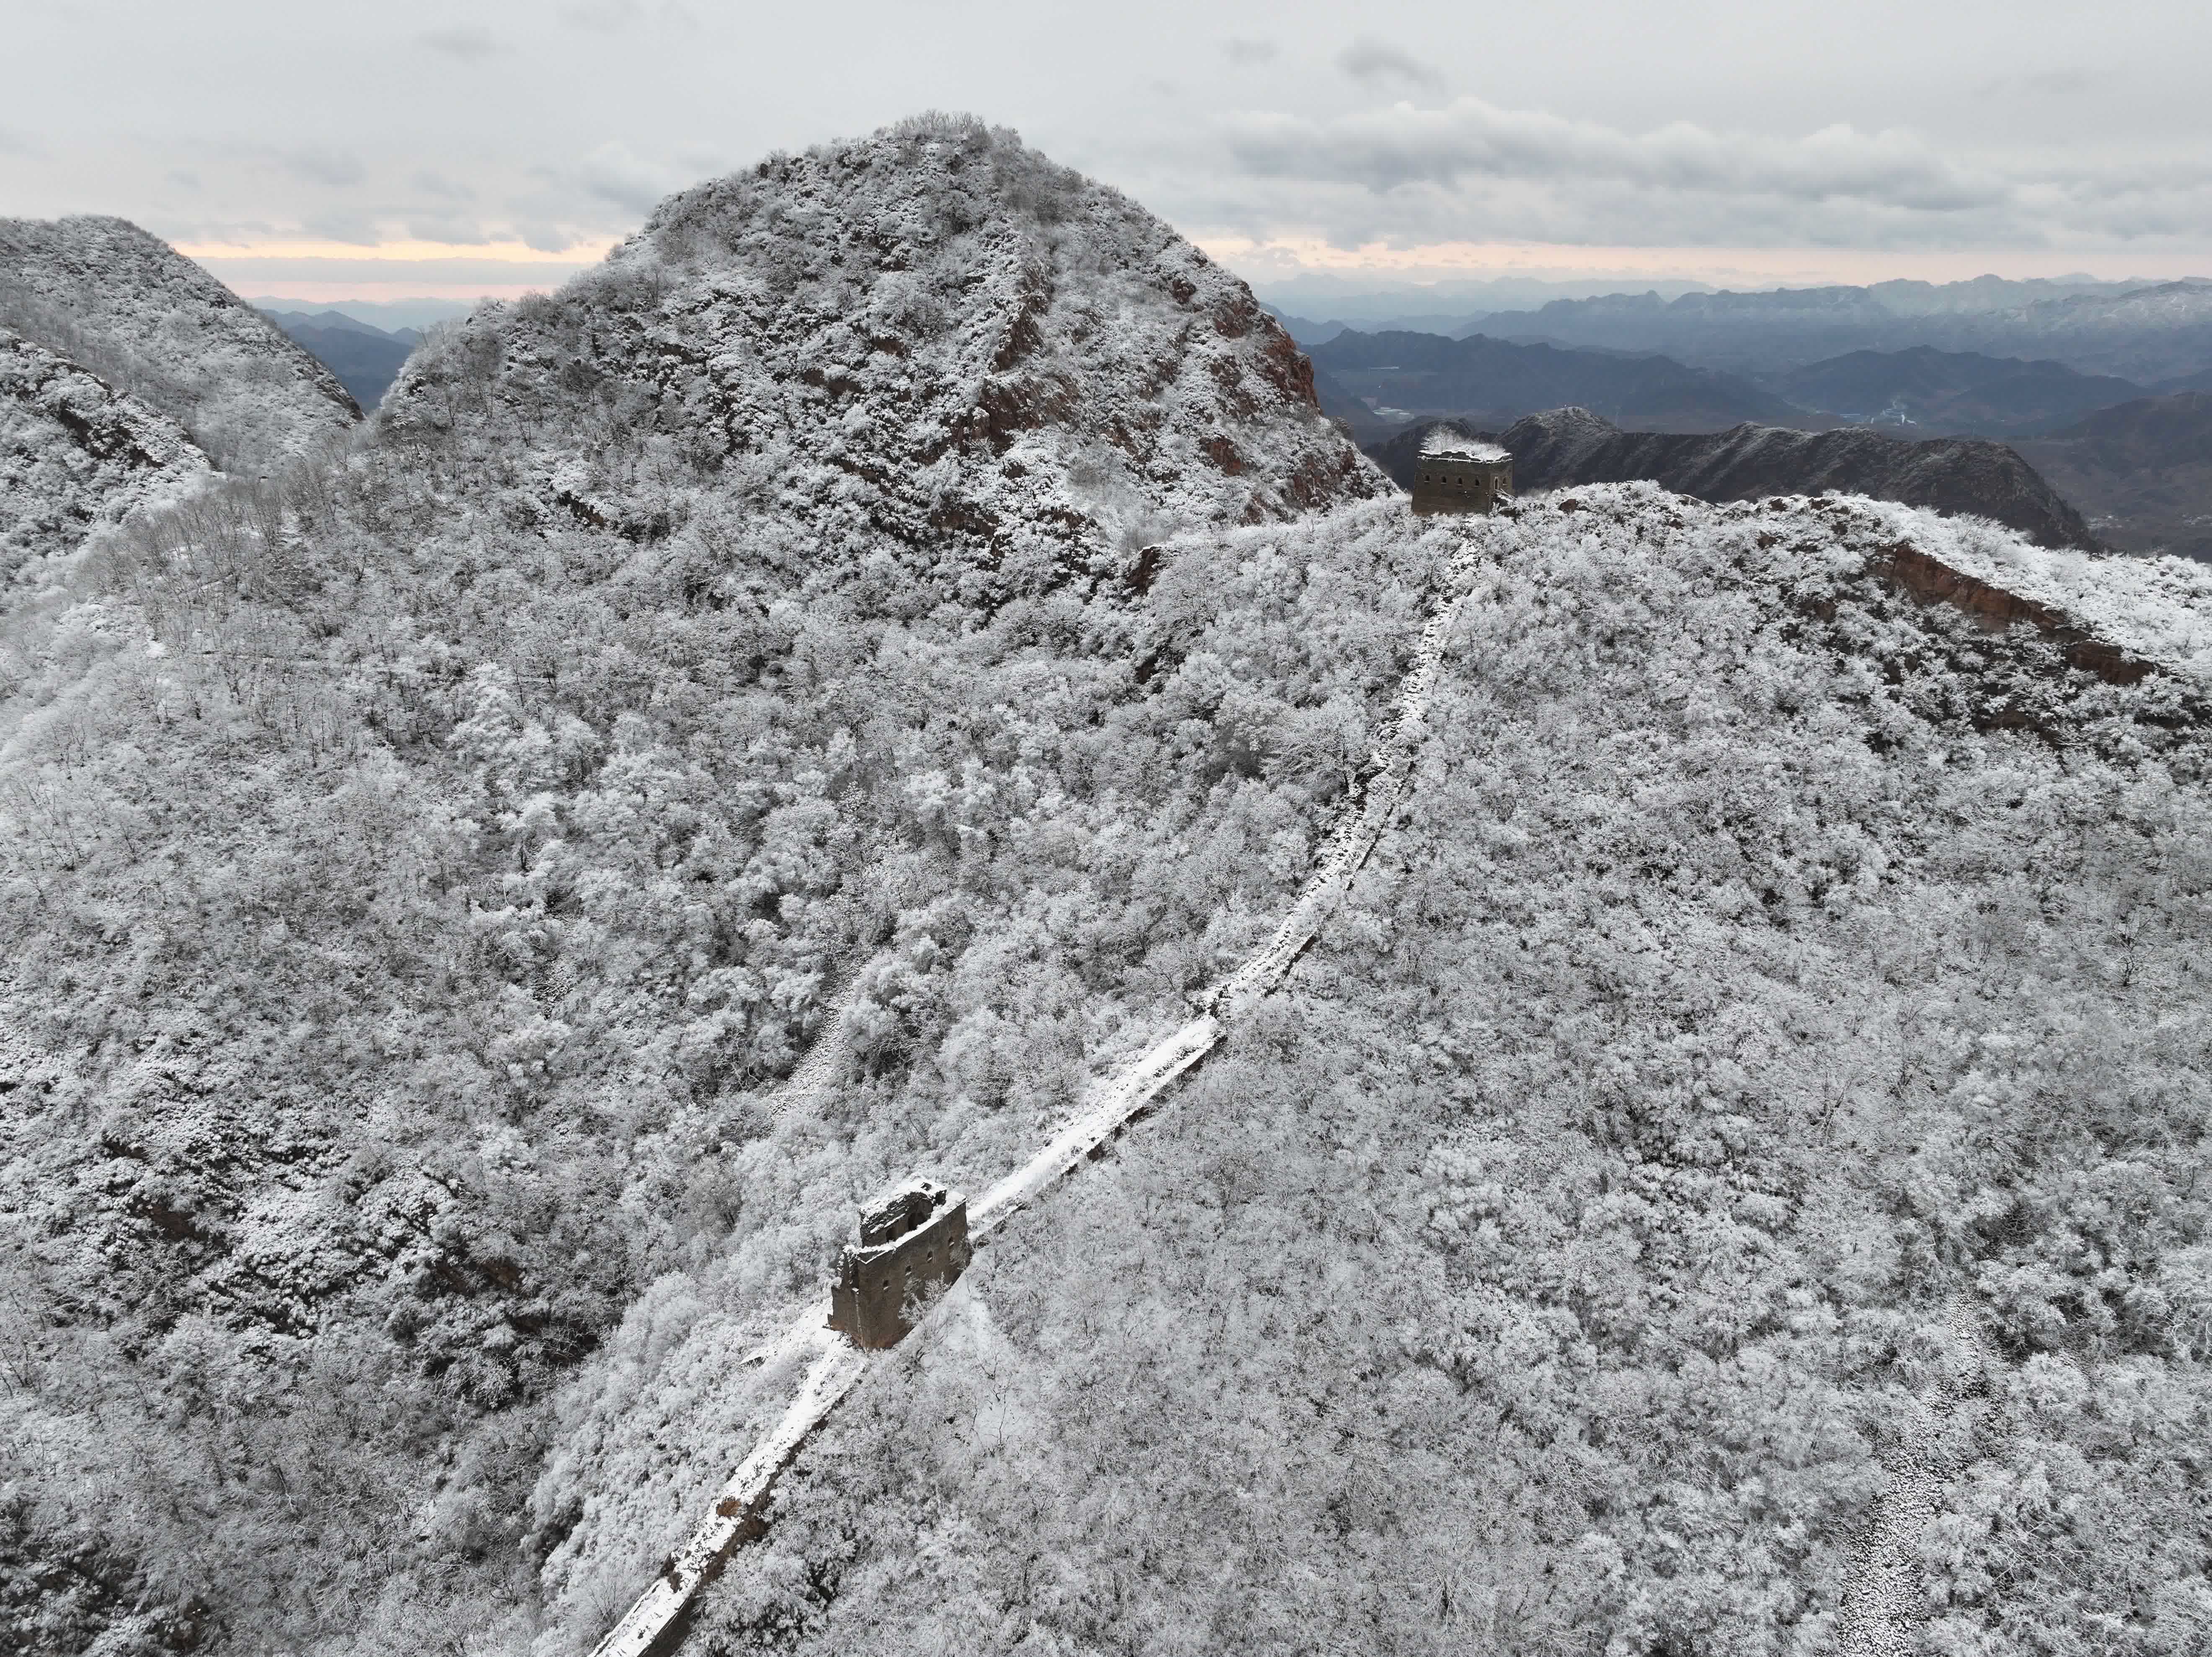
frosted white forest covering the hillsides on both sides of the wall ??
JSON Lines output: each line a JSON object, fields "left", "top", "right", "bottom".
{"left": 0, "top": 121, "right": 2212, "bottom": 1657}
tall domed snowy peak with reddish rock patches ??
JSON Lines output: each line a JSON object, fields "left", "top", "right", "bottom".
{"left": 380, "top": 117, "right": 1389, "bottom": 597}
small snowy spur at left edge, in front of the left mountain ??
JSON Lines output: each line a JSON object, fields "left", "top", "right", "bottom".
{"left": 0, "top": 328, "right": 210, "bottom": 582}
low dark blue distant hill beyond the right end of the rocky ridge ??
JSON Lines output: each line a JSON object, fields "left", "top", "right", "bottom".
{"left": 1774, "top": 345, "right": 2143, "bottom": 434}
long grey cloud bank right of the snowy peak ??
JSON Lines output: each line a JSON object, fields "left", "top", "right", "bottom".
{"left": 1225, "top": 97, "right": 2006, "bottom": 212}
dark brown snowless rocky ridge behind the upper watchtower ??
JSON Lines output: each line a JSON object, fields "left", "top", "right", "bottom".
{"left": 1369, "top": 409, "right": 2097, "bottom": 549}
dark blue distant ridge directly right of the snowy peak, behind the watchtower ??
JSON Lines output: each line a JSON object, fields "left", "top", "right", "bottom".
{"left": 1312, "top": 330, "right": 1796, "bottom": 427}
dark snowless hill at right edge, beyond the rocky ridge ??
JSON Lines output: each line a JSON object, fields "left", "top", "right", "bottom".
{"left": 2020, "top": 392, "right": 2212, "bottom": 560}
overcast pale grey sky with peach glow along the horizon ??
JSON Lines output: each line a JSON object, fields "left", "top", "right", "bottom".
{"left": 0, "top": 0, "right": 2212, "bottom": 297}
